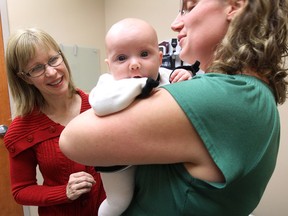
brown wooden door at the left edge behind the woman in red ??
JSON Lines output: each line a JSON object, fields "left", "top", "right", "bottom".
{"left": 0, "top": 17, "right": 23, "bottom": 216}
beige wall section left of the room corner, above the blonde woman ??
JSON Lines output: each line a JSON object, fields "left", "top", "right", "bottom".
{"left": 6, "top": 0, "right": 106, "bottom": 73}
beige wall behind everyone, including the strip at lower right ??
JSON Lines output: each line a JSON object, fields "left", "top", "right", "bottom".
{"left": 0, "top": 0, "right": 288, "bottom": 216}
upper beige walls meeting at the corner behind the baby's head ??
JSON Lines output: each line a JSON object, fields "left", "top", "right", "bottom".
{"left": 5, "top": 0, "right": 178, "bottom": 71}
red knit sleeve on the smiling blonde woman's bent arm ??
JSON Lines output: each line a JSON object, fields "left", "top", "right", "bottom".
{"left": 10, "top": 148, "right": 70, "bottom": 206}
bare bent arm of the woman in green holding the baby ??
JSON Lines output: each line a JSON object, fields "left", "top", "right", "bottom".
{"left": 60, "top": 89, "right": 203, "bottom": 166}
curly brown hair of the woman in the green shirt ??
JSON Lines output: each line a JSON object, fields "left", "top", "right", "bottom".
{"left": 208, "top": 0, "right": 288, "bottom": 104}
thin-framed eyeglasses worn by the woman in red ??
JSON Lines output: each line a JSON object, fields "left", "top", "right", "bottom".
{"left": 22, "top": 52, "right": 63, "bottom": 78}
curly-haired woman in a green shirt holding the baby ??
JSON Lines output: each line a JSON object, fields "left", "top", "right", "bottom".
{"left": 60, "top": 0, "right": 288, "bottom": 216}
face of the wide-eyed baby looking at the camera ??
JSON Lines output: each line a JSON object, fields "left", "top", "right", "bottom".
{"left": 106, "top": 23, "right": 162, "bottom": 80}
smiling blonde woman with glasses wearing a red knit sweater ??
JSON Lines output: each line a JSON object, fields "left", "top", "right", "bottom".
{"left": 4, "top": 29, "right": 105, "bottom": 216}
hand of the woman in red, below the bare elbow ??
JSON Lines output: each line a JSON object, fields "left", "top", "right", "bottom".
{"left": 66, "top": 172, "right": 96, "bottom": 200}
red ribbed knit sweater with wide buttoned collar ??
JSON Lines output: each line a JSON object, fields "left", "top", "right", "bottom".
{"left": 4, "top": 90, "right": 105, "bottom": 216}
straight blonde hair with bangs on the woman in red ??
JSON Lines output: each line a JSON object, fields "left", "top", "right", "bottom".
{"left": 5, "top": 28, "right": 76, "bottom": 116}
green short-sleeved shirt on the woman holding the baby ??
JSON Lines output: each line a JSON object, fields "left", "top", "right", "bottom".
{"left": 123, "top": 73, "right": 280, "bottom": 216}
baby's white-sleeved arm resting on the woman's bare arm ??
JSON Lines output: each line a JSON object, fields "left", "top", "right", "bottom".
{"left": 89, "top": 73, "right": 152, "bottom": 116}
